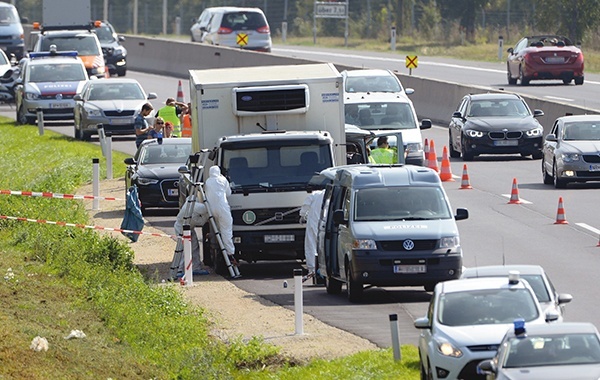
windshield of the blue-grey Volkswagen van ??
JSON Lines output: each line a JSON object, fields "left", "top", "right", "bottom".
{"left": 354, "top": 186, "right": 452, "bottom": 221}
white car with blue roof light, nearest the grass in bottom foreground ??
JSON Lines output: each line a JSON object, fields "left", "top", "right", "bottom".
{"left": 415, "top": 273, "right": 558, "bottom": 379}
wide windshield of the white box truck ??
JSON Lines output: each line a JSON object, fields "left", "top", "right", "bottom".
{"left": 223, "top": 142, "right": 333, "bottom": 191}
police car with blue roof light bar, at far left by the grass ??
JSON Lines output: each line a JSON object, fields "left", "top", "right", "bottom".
{"left": 15, "top": 49, "right": 89, "bottom": 124}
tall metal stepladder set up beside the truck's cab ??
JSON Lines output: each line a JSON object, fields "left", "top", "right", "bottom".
{"left": 170, "top": 149, "right": 240, "bottom": 279}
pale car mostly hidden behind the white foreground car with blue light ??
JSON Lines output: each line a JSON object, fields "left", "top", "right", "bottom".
{"left": 461, "top": 265, "right": 573, "bottom": 321}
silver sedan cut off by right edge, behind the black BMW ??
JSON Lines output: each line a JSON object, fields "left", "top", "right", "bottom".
{"left": 542, "top": 115, "right": 600, "bottom": 188}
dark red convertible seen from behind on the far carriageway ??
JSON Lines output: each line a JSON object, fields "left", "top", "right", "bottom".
{"left": 506, "top": 35, "right": 583, "bottom": 86}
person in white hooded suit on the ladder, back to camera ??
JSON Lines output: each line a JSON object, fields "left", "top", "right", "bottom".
{"left": 204, "top": 166, "right": 235, "bottom": 256}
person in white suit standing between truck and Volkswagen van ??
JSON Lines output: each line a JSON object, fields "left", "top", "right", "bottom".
{"left": 300, "top": 190, "right": 325, "bottom": 279}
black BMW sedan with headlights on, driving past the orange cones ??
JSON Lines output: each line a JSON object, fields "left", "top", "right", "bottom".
{"left": 448, "top": 93, "right": 544, "bottom": 161}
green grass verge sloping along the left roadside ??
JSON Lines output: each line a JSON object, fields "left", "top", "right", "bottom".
{"left": 0, "top": 118, "right": 419, "bottom": 379}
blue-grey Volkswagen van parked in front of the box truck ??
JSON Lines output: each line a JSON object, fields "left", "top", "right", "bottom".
{"left": 317, "top": 165, "right": 469, "bottom": 302}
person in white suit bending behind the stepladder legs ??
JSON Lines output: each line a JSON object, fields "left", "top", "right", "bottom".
{"left": 173, "top": 195, "right": 208, "bottom": 276}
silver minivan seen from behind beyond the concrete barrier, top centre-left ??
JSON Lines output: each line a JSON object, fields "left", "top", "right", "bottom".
{"left": 203, "top": 7, "right": 272, "bottom": 52}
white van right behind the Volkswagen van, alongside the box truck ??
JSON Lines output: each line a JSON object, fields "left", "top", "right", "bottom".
{"left": 344, "top": 92, "right": 431, "bottom": 166}
